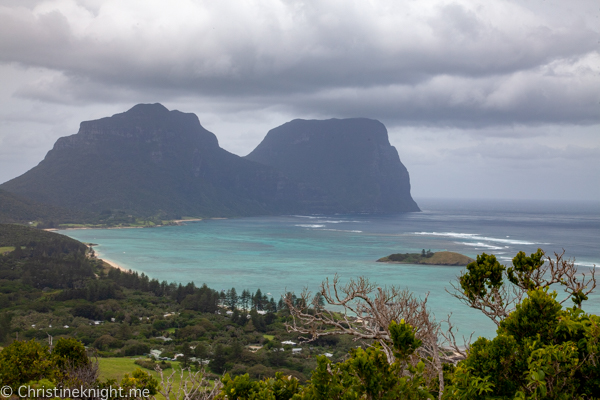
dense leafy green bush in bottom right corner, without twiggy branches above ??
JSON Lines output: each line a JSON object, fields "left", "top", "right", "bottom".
{"left": 447, "top": 289, "right": 600, "bottom": 400}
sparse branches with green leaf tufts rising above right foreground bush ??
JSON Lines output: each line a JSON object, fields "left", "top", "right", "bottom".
{"left": 447, "top": 249, "right": 596, "bottom": 326}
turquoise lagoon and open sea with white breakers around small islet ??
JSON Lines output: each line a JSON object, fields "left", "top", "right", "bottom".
{"left": 61, "top": 200, "right": 600, "bottom": 336}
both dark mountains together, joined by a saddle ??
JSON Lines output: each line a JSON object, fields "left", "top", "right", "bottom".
{"left": 0, "top": 104, "right": 419, "bottom": 217}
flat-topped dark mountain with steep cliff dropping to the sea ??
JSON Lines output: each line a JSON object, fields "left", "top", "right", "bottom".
{"left": 245, "top": 118, "right": 419, "bottom": 213}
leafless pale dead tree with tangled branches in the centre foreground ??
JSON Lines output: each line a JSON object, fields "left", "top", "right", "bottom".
{"left": 284, "top": 275, "right": 452, "bottom": 398}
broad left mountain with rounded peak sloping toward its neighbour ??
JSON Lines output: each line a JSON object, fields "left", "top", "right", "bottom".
{"left": 1, "top": 104, "right": 295, "bottom": 218}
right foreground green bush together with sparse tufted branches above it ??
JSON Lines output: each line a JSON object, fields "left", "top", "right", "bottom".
{"left": 448, "top": 250, "right": 600, "bottom": 400}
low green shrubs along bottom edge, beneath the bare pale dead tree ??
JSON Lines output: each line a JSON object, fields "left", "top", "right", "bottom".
{"left": 217, "top": 321, "right": 433, "bottom": 400}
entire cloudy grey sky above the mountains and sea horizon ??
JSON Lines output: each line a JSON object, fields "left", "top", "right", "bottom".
{"left": 0, "top": 0, "right": 600, "bottom": 200}
